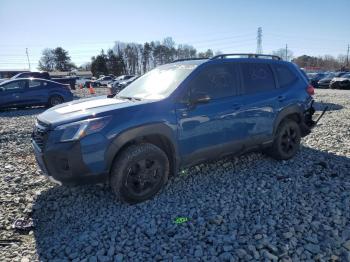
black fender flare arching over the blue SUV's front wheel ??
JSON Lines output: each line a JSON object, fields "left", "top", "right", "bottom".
{"left": 105, "top": 122, "right": 180, "bottom": 176}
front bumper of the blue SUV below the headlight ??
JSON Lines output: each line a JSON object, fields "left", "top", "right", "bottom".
{"left": 32, "top": 137, "right": 108, "bottom": 185}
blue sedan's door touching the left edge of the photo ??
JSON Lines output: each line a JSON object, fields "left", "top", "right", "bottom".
{"left": 0, "top": 80, "right": 26, "bottom": 107}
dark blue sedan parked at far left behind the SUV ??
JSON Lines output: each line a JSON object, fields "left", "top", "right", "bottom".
{"left": 0, "top": 78, "right": 73, "bottom": 108}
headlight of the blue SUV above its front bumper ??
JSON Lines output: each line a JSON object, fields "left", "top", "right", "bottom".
{"left": 55, "top": 117, "right": 111, "bottom": 142}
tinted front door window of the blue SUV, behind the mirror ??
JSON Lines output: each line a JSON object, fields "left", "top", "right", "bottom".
{"left": 190, "top": 64, "right": 239, "bottom": 99}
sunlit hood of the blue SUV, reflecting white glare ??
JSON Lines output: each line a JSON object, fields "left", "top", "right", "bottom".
{"left": 38, "top": 96, "right": 147, "bottom": 127}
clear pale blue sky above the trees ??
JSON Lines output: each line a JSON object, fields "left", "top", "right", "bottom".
{"left": 0, "top": 0, "right": 350, "bottom": 70}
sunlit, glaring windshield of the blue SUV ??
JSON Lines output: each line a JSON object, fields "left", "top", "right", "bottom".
{"left": 118, "top": 64, "right": 197, "bottom": 99}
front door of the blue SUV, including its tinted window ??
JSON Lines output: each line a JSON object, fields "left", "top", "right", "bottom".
{"left": 176, "top": 64, "right": 240, "bottom": 165}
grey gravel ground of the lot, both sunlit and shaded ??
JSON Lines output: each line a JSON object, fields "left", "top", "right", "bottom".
{"left": 0, "top": 89, "right": 350, "bottom": 262}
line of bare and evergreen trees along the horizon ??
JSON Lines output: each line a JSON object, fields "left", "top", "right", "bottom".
{"left": 39, "top": 37, "right": 346, "bottom": 77}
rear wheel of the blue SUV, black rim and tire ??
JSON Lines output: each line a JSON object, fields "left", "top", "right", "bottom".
{"left": 267, "top": 119, "right": 301, "bottom": 160}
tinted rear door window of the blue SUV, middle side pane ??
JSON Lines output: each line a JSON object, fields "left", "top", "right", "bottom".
{"left": 241, "top": 63, "right": 276, "bottom": 94}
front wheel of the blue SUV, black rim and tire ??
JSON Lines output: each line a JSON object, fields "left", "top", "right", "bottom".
{"left": 110, "top": 143, "right": 169, "bottom": 204}
